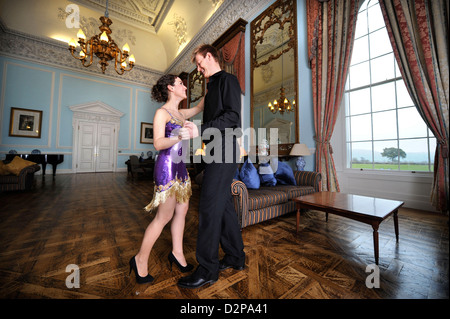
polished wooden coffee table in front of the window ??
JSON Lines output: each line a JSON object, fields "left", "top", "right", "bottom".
{"left": 294, "top": 192, "right": 404, "bottom": 265}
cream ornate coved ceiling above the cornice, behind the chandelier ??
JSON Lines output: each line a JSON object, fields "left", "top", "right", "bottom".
{"left": 0, "top": 0, "right": 225, "bottom": 72}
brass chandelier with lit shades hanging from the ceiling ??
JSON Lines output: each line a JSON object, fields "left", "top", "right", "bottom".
{"left": 69, "top": 0, "right": 136, "bottom": 75}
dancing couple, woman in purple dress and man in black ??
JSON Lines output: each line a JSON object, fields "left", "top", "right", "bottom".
{"left": 130, "top": 44, "right": 245, "bottom": 288}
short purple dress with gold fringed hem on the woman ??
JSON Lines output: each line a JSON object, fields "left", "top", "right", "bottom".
{"left": 144, "top": 110, "right": 192, "bottom": 212}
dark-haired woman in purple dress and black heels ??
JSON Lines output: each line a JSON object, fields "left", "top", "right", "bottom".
{"left": 130, "top": 74, "right": 204, "bottom": 283}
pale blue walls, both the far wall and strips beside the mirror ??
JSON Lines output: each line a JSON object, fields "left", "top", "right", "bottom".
{"left": 0, "top": 0, "right": 315, "bottom": 170}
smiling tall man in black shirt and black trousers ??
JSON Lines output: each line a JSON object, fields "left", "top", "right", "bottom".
{"left": 178, "top": 44, "right": 245, "bottom": 288}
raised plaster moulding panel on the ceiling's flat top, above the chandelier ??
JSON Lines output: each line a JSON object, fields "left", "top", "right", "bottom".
{"left": 72, "top": 0, "right": 173, "bottom": 33}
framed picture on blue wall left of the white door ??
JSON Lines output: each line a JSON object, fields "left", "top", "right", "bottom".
{"left": 9, "top": 107, "right": 42, "bottom": 138}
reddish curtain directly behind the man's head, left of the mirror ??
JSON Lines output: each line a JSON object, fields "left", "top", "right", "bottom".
{"left": 219, "top": 32, "right": 245, "bottom": 94}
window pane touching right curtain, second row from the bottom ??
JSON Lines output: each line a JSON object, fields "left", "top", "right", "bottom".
{"left": 398, "top": 107, "right": 427, "bottom": 138}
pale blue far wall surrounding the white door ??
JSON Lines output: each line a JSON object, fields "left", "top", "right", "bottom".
{"left": 0, "top": 56, "right": 160, "bottom": 170}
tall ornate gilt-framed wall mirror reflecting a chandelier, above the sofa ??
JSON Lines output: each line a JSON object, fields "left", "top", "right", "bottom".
{"left": 250, "top": 0, "right": 299, "bottom": 155}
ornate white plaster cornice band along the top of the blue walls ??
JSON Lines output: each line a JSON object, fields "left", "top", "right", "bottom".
{"left": 0, "top": 0, "right": 274, "bottom": 86}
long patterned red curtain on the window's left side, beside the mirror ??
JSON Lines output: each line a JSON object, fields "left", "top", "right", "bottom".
{"left": 307, "top": 0, "right": 363, "bottom": 192}
